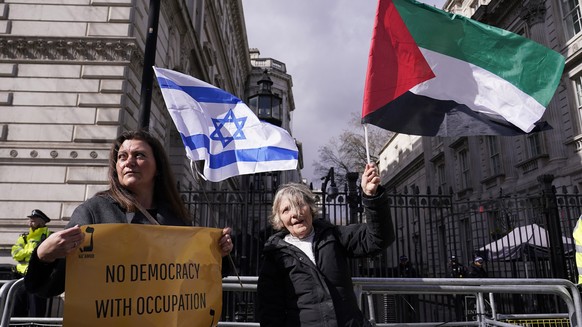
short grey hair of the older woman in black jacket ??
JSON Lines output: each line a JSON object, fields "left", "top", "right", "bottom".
{"left": 269, "top": 183, "right": 317, "bottom": 231}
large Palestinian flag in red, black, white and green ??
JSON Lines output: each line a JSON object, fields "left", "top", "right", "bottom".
{"left": 362, "top": 0, "right": 564, "bottom": 136}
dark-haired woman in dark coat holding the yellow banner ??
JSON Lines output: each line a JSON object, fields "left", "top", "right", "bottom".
{"left": 25, "top": 131, "right": 233, "bottom": 297}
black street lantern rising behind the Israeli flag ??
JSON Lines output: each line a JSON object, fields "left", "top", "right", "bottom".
{"left": 249, "top": 69, "right": 283, "bottom": 127}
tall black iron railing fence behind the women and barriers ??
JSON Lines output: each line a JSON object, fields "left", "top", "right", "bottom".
{"left": 182, "top": 176, "right": 582, "bottom": 321}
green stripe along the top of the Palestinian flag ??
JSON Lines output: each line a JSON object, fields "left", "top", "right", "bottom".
{"left": 392, "top": 0, "right": 564, "bottom": 107}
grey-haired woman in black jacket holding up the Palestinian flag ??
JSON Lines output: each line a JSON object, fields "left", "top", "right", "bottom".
{"left": 258, "top": 164, "right": 394, "bottom": 327}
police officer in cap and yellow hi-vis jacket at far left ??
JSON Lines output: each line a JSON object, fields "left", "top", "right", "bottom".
{"left": 11, "top": 209, "right": 52, "bottom": 317}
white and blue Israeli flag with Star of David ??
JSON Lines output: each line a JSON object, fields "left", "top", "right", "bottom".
{"left": 154, "top": 67, "right": 299, "bottom": 182}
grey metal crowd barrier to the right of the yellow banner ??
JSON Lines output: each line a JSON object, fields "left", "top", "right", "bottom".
{"left": 223, "top": 277, "right": 582, "bottom": 327}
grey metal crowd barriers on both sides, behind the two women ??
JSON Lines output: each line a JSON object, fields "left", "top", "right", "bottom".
{"left": 0, "top": 277, "right": 582, "bottom": 327}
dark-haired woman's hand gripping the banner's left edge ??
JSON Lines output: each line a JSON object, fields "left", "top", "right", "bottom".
{"left": 36, "top": 225, "right": 85, "bottom": 263}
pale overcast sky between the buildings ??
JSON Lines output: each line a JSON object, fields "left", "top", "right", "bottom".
{"left": 243, "top": 0, "right": 445, "bottom": 187}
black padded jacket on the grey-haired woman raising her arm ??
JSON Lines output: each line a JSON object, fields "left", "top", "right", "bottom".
{"left": 257, "top": 192, "right": 394, "bottom": 327}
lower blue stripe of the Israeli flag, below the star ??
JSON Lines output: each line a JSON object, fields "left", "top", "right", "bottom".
{"left": 181, "top": 134, "right": 299, "bottom": 169}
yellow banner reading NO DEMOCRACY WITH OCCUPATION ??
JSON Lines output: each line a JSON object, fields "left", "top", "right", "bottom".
{"left": 63, "top": 224, "right": 222, "bottom": 327}
